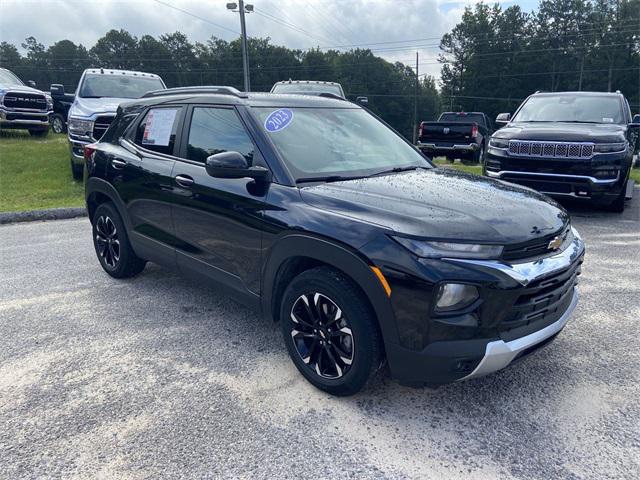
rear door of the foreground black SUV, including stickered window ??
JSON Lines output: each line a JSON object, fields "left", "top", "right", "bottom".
{"left": 107, "top": 106, "right": 184, "bottom": 265}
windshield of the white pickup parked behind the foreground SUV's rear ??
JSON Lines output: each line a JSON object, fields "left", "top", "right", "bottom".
{"left": 79, "top": 74, "right": 165, "bottom": 98}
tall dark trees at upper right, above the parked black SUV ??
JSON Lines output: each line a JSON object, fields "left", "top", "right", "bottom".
{"left": 439, "top": 0, "right": 640, "bottom": 115}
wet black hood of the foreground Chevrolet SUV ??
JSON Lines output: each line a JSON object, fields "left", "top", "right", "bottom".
{"left": 301, "top": 168, "right": 569, "bottom": 244}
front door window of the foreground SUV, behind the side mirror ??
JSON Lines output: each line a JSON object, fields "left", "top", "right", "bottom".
{"left": 187, "top": 107, "right": 254, "bottom": 165}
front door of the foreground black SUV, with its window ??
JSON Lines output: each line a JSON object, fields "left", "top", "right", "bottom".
{"left": 173, "top": 105, "right": 268, "bottom": 296}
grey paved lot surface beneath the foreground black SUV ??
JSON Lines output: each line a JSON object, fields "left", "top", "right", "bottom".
{"left": 0, "top": 189, "right": 640, "bottom": 479}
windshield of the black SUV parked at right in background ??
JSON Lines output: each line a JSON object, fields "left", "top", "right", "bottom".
{"left": 513, "top": 93, "right": 623, "bottom": 123}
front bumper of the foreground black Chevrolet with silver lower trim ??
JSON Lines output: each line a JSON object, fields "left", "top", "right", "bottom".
{"left": 385, "top": 226, "right": 585, "bottom": 386}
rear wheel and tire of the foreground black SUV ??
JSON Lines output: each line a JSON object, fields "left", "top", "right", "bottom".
{"left": 91, "top": 202, "right": 146, "bottom": 278}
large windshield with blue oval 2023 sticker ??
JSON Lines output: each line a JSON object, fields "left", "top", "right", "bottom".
{"left": 253, "top": 107, "right": 431, "bottom": 179}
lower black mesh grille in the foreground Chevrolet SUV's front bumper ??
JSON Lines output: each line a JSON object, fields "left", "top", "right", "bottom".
{"left": 499, "top": 260, "right": 582, "bottom": 333}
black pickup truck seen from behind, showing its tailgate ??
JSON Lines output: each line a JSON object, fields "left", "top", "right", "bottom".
{"left": 418, "top": 112, "right": 493, "bottom": 163}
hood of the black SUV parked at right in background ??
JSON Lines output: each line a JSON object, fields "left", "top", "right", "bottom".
{"left": 493, "top": 122, "right": 627, "bottom": 143}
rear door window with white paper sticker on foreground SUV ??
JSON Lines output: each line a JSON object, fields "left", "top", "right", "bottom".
{"left": 133, "top": 107, "right": 180, "bottom": 155}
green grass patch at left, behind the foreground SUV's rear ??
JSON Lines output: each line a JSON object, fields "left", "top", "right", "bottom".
{"left": 0, "top": 131, "right": 84, "bottom": 212}
